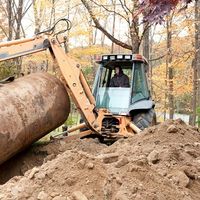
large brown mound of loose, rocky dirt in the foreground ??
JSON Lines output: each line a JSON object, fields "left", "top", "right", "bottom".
{"left": 0, "top": 120, "right": 200, "bottom": 200}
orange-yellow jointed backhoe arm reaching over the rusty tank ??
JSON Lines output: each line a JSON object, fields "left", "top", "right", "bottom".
{"left": 0, "top": 35, "right": 98, "bottom": 132}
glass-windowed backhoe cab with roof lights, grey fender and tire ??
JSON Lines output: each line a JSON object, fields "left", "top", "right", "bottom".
{"left": 93, "top": 54, "right": 156, "bottom": 129}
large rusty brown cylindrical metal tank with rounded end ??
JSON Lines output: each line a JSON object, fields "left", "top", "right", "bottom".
{"left": 0, "top": 73, "right": 70, "bottom": 164}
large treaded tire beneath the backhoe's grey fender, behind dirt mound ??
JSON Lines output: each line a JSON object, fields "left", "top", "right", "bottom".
{"left": 132, "top": 108, "right": 156, "bottom": 130}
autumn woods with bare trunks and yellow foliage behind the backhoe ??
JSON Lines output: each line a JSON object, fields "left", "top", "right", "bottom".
{"left": 0, "top": 0, "right": 200, "bottom": 125}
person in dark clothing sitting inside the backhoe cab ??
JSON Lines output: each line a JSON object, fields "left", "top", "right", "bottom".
{"left": 110, "top": 66, "right": 130, "bottom": 87}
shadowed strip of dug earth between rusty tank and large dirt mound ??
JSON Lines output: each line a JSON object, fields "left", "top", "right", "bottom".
{"left": 0, "top": 137, "right": 105, "bottom": 184}
